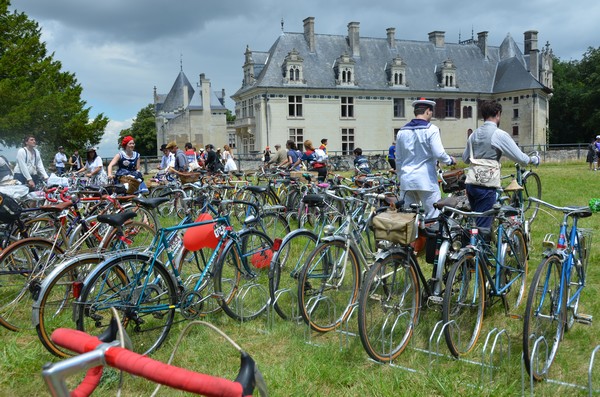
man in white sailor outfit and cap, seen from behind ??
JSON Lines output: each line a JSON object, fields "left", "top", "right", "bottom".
{"left": 396, "top": 98, "right": 456, "bottom": 218}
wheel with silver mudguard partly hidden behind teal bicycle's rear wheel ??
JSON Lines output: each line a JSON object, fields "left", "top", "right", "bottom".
{"left": 32, "top": 254, "right": 103, "bottom": 357}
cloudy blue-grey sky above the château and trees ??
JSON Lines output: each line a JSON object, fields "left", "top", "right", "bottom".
{"left": 4, "top": 0, "right": 600, "bottom": 157}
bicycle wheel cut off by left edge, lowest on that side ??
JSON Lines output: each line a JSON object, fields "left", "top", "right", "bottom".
{"left": 0, "top": 237, "right": 63, "bottom": 331}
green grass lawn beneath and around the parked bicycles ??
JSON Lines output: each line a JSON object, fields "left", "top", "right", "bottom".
{"left": 0, "top": 163, "right": 600, "bottom": 396}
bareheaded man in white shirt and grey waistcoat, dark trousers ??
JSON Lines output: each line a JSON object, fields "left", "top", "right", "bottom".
{"left": 462, "top": 101, "right": 540, "bottom": 227}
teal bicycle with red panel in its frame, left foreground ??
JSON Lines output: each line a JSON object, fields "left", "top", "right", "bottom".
{"left": 74, "top": 207, "right": 273, "bottom": 354}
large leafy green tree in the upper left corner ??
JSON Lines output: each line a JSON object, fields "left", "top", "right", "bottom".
{"left": 0, "top": 0, "right": 108, "bottom": 159}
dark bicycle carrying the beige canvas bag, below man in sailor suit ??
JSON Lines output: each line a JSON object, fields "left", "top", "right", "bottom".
{"left": 358, "top": 197, "right": 472, "bottom": 362}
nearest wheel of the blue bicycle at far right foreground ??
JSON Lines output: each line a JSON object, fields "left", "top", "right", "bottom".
{"left": 523, "top": 255, "right": 567, "bottom": 381}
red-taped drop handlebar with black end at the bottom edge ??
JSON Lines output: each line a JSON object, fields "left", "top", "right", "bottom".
{"left": 43, "top": 328, "right": 255, "bottom": 397}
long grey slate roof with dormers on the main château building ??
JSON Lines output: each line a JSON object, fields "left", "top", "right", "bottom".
{"left": 234, "top": 29, "right": 542, "bottom": 96}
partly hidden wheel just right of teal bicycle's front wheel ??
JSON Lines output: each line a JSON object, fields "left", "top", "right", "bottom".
{"left": 269, "top": 229, "right": 318, "bottom": 320}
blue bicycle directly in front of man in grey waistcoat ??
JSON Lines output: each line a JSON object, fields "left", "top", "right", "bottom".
{"left": 442, "top": 204, "right": 528, "bottom": 357}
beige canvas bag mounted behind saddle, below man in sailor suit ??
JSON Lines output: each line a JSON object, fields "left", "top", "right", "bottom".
{"left": 372, "top": 210, "right": 418, "bottom": 245}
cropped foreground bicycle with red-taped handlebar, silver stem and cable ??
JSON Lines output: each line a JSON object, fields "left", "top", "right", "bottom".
{"left": 42, "top": 321, "right": 267, "bottom": 397}
